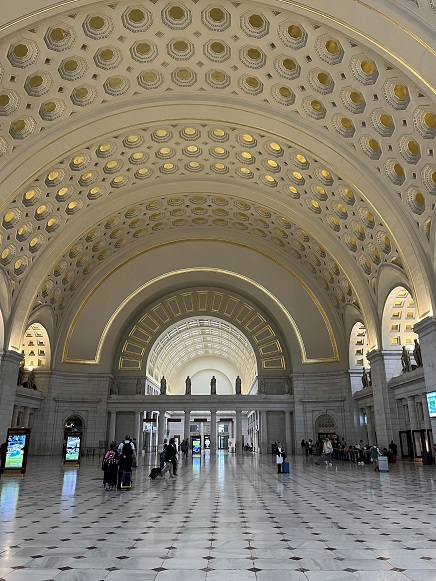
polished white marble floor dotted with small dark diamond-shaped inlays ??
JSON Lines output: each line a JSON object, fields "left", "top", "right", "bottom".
{"left": 0, "top": 452, "right": 436, "bottom": 581}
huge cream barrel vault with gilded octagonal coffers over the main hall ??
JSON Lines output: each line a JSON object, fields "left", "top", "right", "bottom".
{"left": 0, "top": 1, "right": 436, "bottom": 368}
